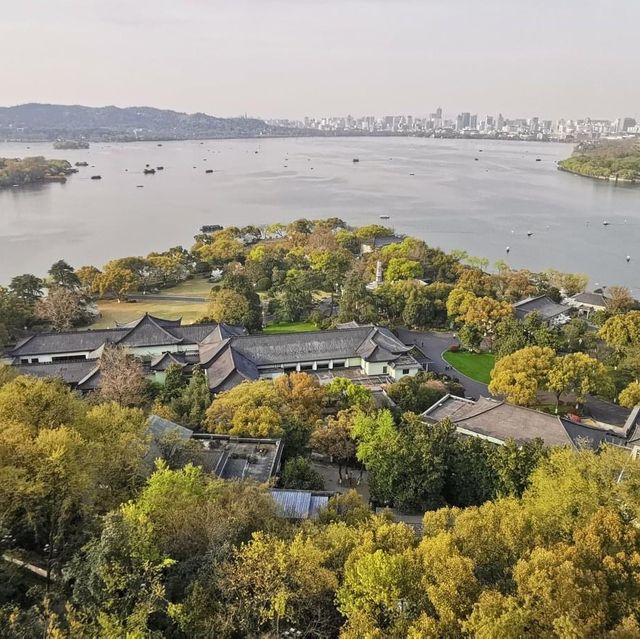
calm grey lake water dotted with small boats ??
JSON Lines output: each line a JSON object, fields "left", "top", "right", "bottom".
{"left": 0, "top": 138, "right": 640, "bottom": 291}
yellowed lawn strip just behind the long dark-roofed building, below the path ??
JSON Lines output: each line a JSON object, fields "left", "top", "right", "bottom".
{"left": 90, "top": 300, "right": 207, "bottom": 328}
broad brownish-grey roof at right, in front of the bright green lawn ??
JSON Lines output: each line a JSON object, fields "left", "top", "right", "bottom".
{"left": 421, "top": 395, "right": 614, "bottom": 448}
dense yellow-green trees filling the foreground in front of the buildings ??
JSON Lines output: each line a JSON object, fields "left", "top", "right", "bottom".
{"left": 0, "top": 368, "right": 640, "bottom": 639}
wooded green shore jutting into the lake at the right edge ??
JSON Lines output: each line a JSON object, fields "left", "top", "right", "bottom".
{"left": 558, "top": 138, "right": 640, "bottom": 182}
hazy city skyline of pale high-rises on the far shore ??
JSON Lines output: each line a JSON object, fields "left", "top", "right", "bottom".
{"left": 270, "top": 107, "right": 640, "bottom": 141}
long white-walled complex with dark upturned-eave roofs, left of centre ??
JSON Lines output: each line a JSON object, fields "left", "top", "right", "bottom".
{"left": 4, "top": 314, "right": 428, "bottom": 394}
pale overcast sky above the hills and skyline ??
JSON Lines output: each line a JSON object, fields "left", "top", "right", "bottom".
{"left": 0, "top": 0, "right": 640, "bottom": 118}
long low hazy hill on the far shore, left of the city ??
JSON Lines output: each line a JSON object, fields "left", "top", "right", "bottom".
{"left": 0, "top": 104, "right": 276, "bottom": 141}
